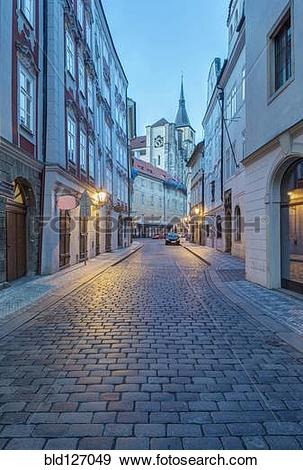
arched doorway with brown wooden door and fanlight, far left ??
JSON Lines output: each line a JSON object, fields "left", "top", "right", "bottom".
{"left": 6, "top": 180, "right": 28, "bottom": 282}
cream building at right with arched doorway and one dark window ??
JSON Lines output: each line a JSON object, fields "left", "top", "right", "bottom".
{"left": 243, "top": 0, "right": 303, "bottom": 293}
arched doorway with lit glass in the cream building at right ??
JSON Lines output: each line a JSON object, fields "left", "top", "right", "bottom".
{"left": 280, "top": 159, "right": 303, "bottom": 294}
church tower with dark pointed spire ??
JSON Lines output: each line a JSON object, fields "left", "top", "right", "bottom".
{"left": 175, "top": 75, "right": 195, "bottom": 182}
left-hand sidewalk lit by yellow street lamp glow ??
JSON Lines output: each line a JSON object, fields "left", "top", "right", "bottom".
{"left": 0, "top": 242, "right": 142, "bottom": 338}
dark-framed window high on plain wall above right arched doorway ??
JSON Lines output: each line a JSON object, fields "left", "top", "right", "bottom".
{"left": 272, "top": 13, "right": 292, "bottom": 91}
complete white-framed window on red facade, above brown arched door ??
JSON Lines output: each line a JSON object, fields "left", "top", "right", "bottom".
{"left": 19, "top": 66, "right": 34, "bottom": 132}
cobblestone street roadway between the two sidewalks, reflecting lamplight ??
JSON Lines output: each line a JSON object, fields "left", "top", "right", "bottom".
{"left": 0, "top": 241, "right": 303, "bottom": 449}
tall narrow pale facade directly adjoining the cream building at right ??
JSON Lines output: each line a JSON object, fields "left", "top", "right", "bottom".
{"left": 218, "top": 0, "right": 246, "bottom": 258}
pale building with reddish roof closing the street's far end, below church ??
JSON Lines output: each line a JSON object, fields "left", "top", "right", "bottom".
{"left": 132, "top": 159, "right": 187, "bottom": 237}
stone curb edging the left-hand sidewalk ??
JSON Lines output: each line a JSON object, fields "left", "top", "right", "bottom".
{"left": 0, "top": 245, "right": 143, "bottom": 340}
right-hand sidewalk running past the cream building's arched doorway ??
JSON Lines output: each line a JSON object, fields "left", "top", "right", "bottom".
{"left": 182, "top": 242, "right": 303, "bottom": 352}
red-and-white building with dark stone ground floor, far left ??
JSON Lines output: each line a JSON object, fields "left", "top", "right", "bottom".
{"left": 0, "top": 1, "right": 44, "bottom": 287}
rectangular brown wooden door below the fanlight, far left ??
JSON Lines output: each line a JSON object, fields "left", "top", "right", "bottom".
{"left": 6, "top": 204, "right": 26, "bottom": 282}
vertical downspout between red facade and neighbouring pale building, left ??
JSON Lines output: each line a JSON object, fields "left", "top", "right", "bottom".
{"left": 38, "top": 0, "right": 48, "bottom": 274}
